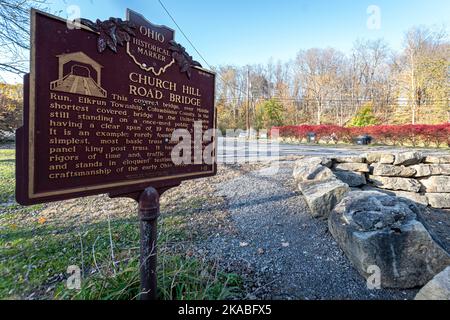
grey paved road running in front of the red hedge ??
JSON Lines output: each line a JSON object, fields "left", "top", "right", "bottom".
{"left": 218, "top": 138, "right": 449, "bottom": 163}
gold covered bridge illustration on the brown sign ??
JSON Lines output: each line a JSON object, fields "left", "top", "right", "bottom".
{"left": 50, "top": 52, "right": 107, "bottom": 98}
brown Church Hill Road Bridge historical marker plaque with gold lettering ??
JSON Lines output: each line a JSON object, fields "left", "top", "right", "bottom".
{"left": 16, "top": 10, "right": 216, "bottom": 205}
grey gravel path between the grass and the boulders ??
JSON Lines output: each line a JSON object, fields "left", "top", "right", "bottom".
{"left": 204, "top": 162, "right": 417, "bottom": 299}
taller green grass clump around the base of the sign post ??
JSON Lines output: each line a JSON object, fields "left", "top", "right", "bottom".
{"left": 56, "top": 254, "right": 242, "bottom": 300}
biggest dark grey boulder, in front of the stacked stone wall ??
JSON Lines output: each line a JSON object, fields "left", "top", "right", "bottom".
{"left": 328, "top": 191, "right": 450, "bottom": 288}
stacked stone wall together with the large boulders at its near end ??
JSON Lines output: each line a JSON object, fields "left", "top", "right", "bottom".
{"left": 293, "top": 152, "right": 450, "bottom": 290}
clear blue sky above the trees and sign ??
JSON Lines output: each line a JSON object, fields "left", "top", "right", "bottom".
{"left": 0, "top": 0, "right": 450, "bottom": 82}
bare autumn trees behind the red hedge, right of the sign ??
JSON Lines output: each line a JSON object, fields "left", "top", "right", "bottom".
{"left": 217, "top": 26, "right": 450, "bottom": 130}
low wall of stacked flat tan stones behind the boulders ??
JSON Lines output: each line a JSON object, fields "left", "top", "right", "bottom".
{"left": 331, "top": 152, "right": 450, "bottom": 209}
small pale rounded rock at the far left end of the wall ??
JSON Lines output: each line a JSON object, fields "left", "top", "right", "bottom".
{"left": 293, "top": 157, "right": 334, "bottom": 182}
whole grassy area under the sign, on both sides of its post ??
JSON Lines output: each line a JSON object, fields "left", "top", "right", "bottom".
{"left": 0, "top": 150, "right": 243, "bottom": 300}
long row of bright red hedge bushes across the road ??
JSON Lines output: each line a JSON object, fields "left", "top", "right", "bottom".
{"left": 271, "top": 123, "right": 450, "bottom": 147}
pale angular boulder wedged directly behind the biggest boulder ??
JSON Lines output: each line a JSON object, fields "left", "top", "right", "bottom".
{"left": 299, "top": 179, "right": 350, "bottom": 218}
